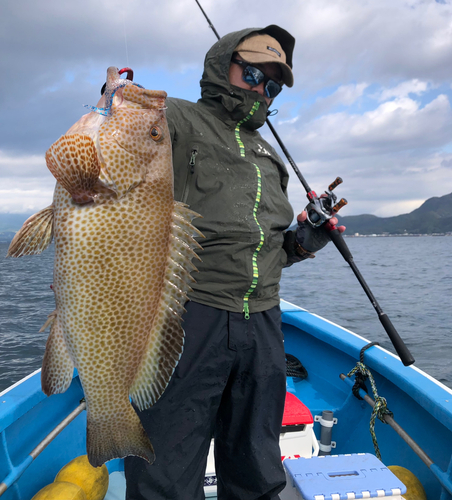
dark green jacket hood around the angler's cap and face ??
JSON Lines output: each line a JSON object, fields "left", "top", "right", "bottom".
{"left": 199, "top": 25, "right": 295, "bottom": 130}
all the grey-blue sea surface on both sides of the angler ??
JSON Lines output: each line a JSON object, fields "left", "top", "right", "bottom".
{"left": 0, "top": 236, "right": 452, "bottom": 391}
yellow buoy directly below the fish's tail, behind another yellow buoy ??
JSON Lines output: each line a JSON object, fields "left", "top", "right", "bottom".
{"left": 55, "top": 455, "right": 109, "bottom": 500}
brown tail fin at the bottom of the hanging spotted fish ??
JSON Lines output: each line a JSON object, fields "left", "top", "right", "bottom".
{"left": 86, "top": 401, "right": 155, "bottom": 467}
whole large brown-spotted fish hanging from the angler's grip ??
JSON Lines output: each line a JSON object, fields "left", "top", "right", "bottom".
{"left": 8, "top": 68, "right": 202, "bottom": 466}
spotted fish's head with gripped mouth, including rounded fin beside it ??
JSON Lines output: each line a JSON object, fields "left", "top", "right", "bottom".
{"left": 46, "top": 67, "right": 173, "bottom": 204}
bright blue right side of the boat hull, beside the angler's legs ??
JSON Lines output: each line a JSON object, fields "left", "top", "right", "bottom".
{"left": 283, "top": 300, "right": 452, "bottom": 500}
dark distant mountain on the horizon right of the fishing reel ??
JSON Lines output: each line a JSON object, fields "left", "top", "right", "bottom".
{"left": 338, "top": 193, "right": 452, "bottom": 235}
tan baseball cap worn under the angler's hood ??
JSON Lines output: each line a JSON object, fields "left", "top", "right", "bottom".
{"left": 234, "top": 33, "right": 293, "bottom": 87}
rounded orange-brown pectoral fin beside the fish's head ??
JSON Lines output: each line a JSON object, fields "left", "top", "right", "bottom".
{"left": 46, "top": 134, "right": 115, "bottom": 204}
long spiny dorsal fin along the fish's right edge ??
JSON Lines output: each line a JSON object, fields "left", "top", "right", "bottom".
{"left": 130, "top": 202, "right": 203, "bottom": 410}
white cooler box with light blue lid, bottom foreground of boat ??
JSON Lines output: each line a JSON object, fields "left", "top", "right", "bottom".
{"left": 284, "top": 453, "right": 406, "bottom": 500}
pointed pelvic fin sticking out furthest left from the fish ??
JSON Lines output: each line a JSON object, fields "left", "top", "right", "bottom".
{"left": 6, "top": 205, "right": 53, "bottom": 257}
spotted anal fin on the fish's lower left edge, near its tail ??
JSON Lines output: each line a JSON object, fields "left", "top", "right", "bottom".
{"left": 41, "top": 311, "right": 74, "bottom": 396}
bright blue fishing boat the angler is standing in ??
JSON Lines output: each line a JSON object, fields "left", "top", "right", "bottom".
{"left": 0, "top": 301, "right": 452, "bottom": 500}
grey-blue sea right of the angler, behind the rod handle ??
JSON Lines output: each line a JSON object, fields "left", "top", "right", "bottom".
{"left": 281, "top": 236, "right": 452, "bottom": 387}
